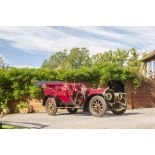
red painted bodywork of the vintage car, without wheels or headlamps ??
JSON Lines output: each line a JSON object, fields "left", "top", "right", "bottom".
{"left": 43, "top": 82, "right": 107, "bottom": 104}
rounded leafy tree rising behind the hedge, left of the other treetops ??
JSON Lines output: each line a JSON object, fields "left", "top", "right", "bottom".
{"left": 42, "top": 48, "right": 91, "bottom": 70}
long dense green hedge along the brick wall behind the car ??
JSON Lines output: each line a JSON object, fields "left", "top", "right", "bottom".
{"left": 0, "top": 64, "right": 138, "bottom": 101}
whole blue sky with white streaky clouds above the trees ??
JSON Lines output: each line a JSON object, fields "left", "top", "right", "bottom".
{"left": 0, "top": 26, "right": 155, "bottom": 68}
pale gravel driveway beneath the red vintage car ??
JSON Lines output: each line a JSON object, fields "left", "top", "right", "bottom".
{"left": 0, "top": 108, "right": 155, "bottom": 129}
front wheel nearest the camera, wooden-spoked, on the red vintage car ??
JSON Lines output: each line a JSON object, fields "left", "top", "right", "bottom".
{"left": 89, "top": 96, "right": 106, "bottom": 117}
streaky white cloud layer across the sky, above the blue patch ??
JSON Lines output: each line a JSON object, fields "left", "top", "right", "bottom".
{"left": 0, "top": 26, "right": 155, "bottom": 53}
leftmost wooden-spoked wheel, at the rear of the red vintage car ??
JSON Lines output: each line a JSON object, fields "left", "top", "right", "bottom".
{"left": 45, "top": 97, "right": 57, "bottom": 116}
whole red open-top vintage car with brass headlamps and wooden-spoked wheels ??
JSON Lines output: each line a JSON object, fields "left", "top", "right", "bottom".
{"left": 42, "top": 81, "right": 126, "bottom": 117}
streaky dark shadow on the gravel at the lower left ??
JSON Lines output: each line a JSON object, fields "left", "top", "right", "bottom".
{"left": 2, "top": 121, "right": 48, "bottom": 129}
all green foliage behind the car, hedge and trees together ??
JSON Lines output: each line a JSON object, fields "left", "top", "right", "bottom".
{"left": 0, "top": 48, "right": 141, "bottom": 101}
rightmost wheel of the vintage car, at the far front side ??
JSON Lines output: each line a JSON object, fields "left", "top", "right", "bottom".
{"left": 111, "top": 99, "right": 127, "bottom": 115}
